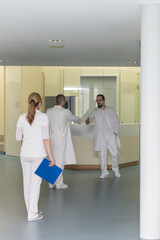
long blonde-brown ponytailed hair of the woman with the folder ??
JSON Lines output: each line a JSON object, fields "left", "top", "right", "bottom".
{"left": 26, "top": 92, "right": 42, "bottom": 125}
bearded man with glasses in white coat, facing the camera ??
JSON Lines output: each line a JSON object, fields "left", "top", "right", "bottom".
{"left": 86, "top": 94, "right": 121, "bottom": 178}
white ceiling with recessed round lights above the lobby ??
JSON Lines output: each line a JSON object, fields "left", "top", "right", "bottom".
{"left": 0, "top": 0, "right": 141, "bottom": 66}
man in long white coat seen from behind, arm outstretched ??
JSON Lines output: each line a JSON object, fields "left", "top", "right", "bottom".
{"left": 46, "top": 94, "right": 81, "bottom": 189}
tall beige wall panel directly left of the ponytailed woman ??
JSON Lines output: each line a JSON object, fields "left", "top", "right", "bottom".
{"left": 5, "top": 67, "right": 21, "bottom": 156}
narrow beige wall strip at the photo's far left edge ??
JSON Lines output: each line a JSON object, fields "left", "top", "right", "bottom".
{"left": 0, "top": 66, "right": 5, "bottom": 136}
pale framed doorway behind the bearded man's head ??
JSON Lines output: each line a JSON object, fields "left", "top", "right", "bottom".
{"left": 79, "top": 76, "right": 118, "bottom": 122}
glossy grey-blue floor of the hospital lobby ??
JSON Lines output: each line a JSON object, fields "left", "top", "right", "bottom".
{"left": 0, "top": 155, "right": 139, "bottom": 240}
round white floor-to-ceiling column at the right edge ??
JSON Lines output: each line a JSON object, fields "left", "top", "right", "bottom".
{"left": 140, "top": 1, "right": 160, "bottom": 239}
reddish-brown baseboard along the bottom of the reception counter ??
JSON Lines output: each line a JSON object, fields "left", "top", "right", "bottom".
{"left": 64, "top": 161, "right": 139, "bottom": 170}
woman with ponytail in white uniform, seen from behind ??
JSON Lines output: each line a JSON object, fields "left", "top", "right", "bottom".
{"left": 16, "top": 93, "right": 55, "bottom": 221}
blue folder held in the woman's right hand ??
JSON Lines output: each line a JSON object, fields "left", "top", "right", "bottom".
{"left": 35, "top": 158, "right": 62, "bottom": 184}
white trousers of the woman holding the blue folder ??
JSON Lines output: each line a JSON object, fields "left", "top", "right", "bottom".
{"left": 21, "top": 157, "right": 43, "bottom": 218}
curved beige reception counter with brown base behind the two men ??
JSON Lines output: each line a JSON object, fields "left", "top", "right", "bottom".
{"left": 66, "top": 124, "right": 140, "bottom": 169}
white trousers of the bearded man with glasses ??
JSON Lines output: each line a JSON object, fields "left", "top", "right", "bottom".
{"left": 99, "top": 135, "right": 119, "bottom": 173}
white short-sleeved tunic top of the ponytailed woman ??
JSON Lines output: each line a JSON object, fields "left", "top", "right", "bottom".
{"left": 16, "top": 110, "right": 49, "bottom": 158}
